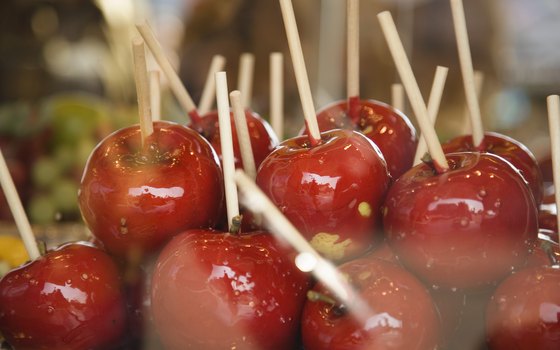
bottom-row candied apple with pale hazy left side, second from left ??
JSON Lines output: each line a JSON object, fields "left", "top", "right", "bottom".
{"left": 151, "top": 230, "right": 310, "bottom": 350}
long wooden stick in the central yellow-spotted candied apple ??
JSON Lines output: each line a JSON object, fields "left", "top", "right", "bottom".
{"left": 280, "top": 0, "right": 321, "bottom": 146}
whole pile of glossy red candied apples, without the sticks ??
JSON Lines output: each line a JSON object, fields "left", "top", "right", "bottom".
{"left": 0, "top": 85, "right": 560, "bottom": 350}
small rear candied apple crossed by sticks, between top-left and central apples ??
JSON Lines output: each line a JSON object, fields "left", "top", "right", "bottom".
{"left": 193, "top": 110, "right": 278, "bottom": 169}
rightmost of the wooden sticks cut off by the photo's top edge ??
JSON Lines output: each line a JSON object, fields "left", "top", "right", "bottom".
{"left": 450, "top": 0, "right": 484, "bottom": 149}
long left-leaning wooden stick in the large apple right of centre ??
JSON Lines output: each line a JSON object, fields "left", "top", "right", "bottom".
{"left": 377, "top": 11, "right": 449, "bottom": 173}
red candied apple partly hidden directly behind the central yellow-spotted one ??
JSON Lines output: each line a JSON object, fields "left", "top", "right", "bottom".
{"left": 317, "top": 100, "right": 418, "bottom": 179}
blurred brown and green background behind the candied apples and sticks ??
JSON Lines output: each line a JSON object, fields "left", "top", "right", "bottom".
{"left": 0, "top": 0, "right": 560, "bottom": 225}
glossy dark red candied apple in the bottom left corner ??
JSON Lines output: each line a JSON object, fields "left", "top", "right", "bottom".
{"left": 0, "top": 242, "right": 126, "bottom": 350}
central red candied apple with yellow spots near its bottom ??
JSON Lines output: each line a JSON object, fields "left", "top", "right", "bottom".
{"left": 256, "top": 129, "right": 390, "bottom": 261}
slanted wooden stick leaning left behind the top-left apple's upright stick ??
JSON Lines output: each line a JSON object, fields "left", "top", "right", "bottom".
{"left": 136, "top": 21, "right": 200, "bottom": 124}
